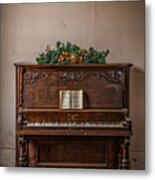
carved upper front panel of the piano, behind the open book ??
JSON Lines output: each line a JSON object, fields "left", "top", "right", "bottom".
{"left": 23, "top": 68, "right": 125, "bottom": 108}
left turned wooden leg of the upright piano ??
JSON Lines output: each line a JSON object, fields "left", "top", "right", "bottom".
{"left": 18, "top": 135, "right": 28, "bottom": 167}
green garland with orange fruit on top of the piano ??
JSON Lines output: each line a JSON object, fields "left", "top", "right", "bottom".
{"left": 36, "top": 41, "right": 109, "bottom": 64}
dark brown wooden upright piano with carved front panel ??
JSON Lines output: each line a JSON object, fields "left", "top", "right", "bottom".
{"left": 15, "top": 63, "right": 132, "bottom": 169}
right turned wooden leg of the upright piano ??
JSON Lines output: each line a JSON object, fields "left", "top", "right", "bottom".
{"left": 121, "top": 138, "right": 130, "bottom": 169}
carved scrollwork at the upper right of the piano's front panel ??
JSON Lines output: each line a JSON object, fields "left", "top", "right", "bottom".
{"left": 96, "top": 70, "right": 122, "bottom": 84}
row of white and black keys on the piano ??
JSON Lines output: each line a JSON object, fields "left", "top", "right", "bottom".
{"left": 27, "top": 121, "right": 128, "bottom": 128}
